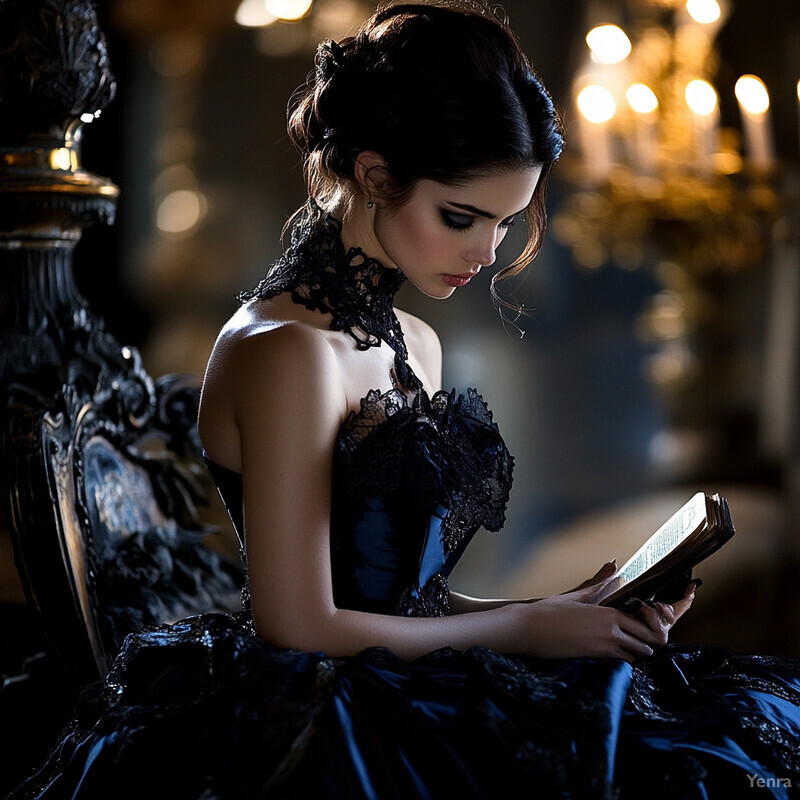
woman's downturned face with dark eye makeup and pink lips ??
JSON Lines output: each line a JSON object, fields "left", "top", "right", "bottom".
{"left": 375, "top": 166, "right": 542, "bottom": 299}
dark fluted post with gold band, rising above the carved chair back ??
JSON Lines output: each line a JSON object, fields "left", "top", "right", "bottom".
{"left": 0, "top": 0, "right": 159, "bottom": 408}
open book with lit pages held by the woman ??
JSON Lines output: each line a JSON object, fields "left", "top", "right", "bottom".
{"left": 600, "top": 492, "right": 734, "bottom": 608}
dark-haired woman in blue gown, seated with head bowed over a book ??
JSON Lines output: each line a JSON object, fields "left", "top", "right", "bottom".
{"left": 10, "top": 0, "right": 800, "bottom": 800}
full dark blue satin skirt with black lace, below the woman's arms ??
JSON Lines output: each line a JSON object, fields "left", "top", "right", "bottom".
{"left": 9, "top": 614, "right": 800, "bottom": 800}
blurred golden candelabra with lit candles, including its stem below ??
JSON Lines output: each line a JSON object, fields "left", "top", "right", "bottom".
{"left": 552, "top": 0, "right": 780, "bottom": 477}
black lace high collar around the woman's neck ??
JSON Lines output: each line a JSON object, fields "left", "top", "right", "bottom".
{"left": 239, "top": 200, "right": 422, "bottom": 392}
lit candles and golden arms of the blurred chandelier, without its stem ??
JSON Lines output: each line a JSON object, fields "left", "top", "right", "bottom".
{"left": 553, "top": 0, "right": 777, "bottom": 271}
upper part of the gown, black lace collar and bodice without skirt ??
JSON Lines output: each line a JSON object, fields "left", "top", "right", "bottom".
{"left": 209, "top": 202, "right": 513, "bottom": 616}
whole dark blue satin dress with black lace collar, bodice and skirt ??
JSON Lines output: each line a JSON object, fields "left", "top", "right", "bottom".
{"left": 11, "top": 203, "right": 800, "bottom": 800}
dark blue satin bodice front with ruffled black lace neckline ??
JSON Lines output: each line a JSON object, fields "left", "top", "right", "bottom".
{"left": 331, "top": 389, "right": 513, "bottom": 616}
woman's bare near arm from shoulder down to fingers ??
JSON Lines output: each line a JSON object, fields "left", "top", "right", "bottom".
{"left": 222, "top": 325, "right": 692, "bottom": 660}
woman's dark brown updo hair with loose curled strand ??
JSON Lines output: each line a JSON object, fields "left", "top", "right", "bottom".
{"left": 289, "top": 0, "right": 563, "bottom": 302}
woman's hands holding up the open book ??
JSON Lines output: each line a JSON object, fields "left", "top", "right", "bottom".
{"left": 522, "top": 576, "right": 694, "bottom": 661}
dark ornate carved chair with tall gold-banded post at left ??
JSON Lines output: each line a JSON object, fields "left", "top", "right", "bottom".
{"left": 0, "top": 0, "right": 241, "bottom": 788}
